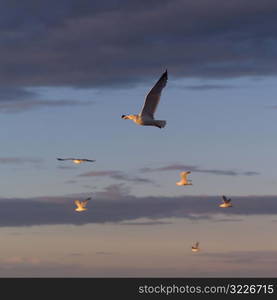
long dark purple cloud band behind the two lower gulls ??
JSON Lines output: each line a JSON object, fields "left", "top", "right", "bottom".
{"left": 0, "top": 192, "right": 277, "bottom": 227}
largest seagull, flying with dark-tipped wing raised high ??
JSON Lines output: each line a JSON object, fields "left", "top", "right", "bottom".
{"left": 121, "top": 70, "right": 167, "bottom": 128}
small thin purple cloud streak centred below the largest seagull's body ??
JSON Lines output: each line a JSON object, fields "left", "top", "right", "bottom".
{"left": 78, "top": 170, "right": 153, "bottom": 183}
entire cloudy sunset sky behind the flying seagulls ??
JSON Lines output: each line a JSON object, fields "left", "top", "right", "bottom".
{"left": 0, "top": 0, "right": 277, "bottom": 277}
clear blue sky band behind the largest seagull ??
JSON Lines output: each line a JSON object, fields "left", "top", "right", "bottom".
{"left": 1, "top": 75, "right": 277, "bottom": 197}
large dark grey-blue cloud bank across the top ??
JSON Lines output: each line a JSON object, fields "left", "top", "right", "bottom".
{"left": 0, "top": 0, "right": 277, "bottom": 87}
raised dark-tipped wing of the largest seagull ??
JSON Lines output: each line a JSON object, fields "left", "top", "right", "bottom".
{"left": 140, "top": 70, "right": 167, "bottom": 118}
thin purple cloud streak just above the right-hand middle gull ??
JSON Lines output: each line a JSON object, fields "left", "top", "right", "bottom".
{"left": 140, "top": 164, "right": 260, "bottom": 176}
